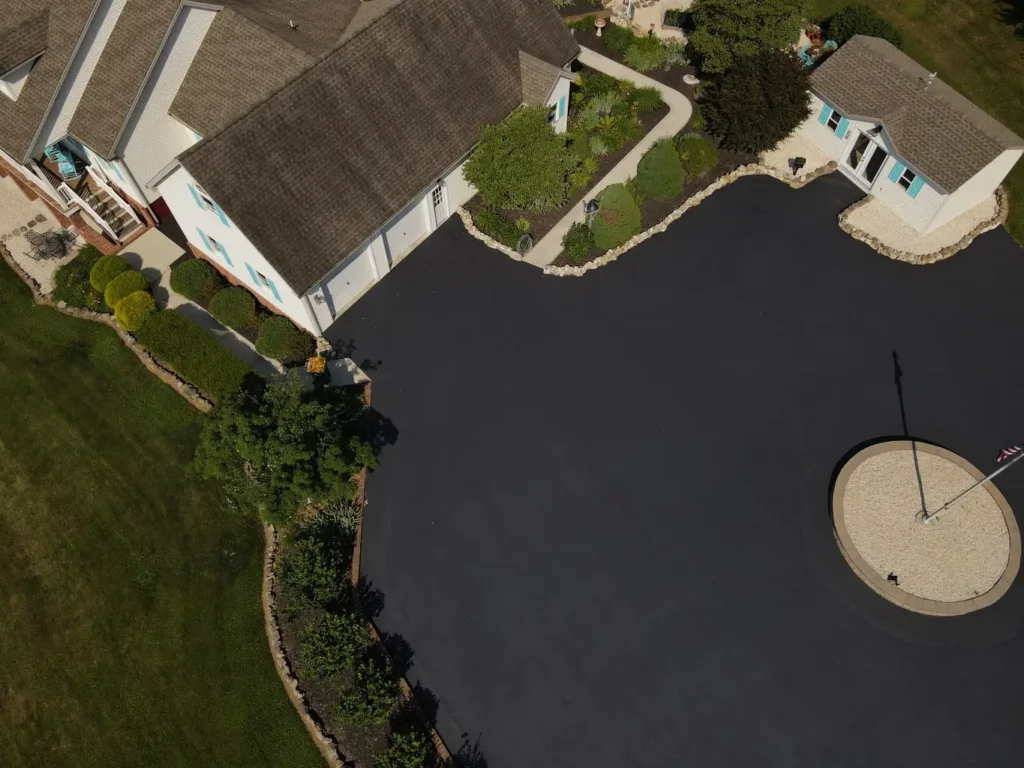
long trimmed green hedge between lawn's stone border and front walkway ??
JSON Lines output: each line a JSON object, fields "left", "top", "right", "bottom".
{"left": 138, "top": 309, "right": 252, "bottom": 400}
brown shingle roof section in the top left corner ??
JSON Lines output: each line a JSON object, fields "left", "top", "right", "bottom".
{"left": 0, "top": 0, "right": 96, "bottom": 161}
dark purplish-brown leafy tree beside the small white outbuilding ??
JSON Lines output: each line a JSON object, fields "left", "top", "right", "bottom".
{"left": 703, "top": 50, "right": 810, "bottom": 153}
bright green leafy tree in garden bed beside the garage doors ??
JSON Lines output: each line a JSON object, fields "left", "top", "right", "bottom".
{"left": 464, "top": 106, "right": 580, "bottom": 211}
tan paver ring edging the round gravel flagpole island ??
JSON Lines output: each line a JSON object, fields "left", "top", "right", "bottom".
{"left": 831, "top": 440, "right": 1021, "bottom": 616}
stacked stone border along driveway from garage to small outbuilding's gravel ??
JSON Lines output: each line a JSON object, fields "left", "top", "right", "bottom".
{"left": 459, "top": 161, "right": 839, "bottom": 278}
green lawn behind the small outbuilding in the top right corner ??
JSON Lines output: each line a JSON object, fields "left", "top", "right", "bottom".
{"left": 809, "top": 0, "right": 1024, "bottom": 245}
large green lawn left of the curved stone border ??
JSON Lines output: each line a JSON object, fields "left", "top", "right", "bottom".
{"left": 0, "top": 262, "right": 322, "bottom": 768}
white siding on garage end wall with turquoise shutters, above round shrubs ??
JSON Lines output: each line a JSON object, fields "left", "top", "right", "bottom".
{"left": 158, "top": 168, "right": 318, "bottom": 334}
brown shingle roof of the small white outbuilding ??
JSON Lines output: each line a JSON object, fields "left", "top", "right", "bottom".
{"left": 811, "top": 35, "right": 1024, "bottom": 193}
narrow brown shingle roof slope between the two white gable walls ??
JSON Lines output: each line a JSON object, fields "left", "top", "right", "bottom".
{"left": 68, "top": 0, "right": 180, "bottom": 160}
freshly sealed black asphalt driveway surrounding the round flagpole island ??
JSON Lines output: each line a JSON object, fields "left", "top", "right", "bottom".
{"left": 332, "top": 177, "right": 1024, "bottom": 768}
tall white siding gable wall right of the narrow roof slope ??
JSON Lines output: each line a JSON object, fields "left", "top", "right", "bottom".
{"left": 118, "top": 5, "right": 216, "bottom": 203}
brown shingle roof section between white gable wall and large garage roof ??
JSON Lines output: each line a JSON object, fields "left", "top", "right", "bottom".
{"left": 170, "top": 8, "right": 316, "bottom": 136}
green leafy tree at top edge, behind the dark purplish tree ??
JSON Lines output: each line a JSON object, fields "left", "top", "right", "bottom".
{"left": 689, "top": 0, "right": 804, "bottom": 74}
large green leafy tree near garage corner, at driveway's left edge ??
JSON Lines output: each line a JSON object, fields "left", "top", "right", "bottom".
{"left": 196, "top": 376, "right": 377, "bottom": 523}
